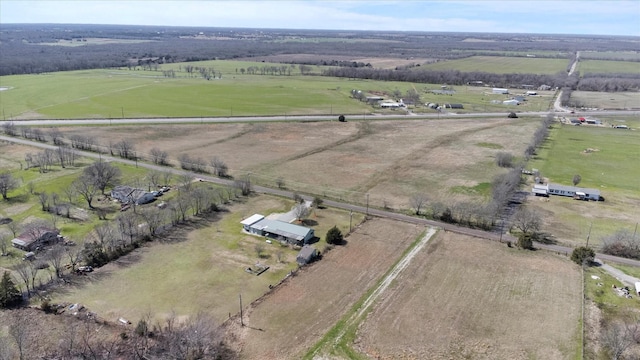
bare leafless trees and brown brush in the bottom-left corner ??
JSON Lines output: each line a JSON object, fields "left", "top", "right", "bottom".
{"left": 0, "top": 310, "right": 236, "bottom": 360}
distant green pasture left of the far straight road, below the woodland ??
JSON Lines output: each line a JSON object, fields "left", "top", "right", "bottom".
{"left": 416, "top": 56, "right": 569, "bottom": 74}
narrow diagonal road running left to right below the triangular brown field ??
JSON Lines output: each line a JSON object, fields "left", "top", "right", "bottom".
{"left": 0, "top": 133, "right": 640, "bottom": 267}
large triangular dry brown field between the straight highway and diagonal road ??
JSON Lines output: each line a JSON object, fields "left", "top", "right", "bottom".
{"left": 53, "top": 117, "right": 539, "bottom": 209}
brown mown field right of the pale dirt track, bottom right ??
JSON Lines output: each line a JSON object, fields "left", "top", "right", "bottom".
{"left": 354, "top": 232, "right": 581, "bottom": 359}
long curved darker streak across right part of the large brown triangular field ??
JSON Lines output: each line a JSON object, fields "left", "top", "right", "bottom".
{"left": 351, "top": 121, "right": 508, "bottom": 193}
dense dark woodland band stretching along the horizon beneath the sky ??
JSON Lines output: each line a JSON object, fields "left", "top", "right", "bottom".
{"left": 0, "top": 24, "right": 628, "bottom": 75}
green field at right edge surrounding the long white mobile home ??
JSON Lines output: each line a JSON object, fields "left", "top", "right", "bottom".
{"left": 528, "top": 118, "right": 640, "bottom": 246}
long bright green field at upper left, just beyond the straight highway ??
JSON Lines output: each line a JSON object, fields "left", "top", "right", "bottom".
{"left": 0, "top": 61, "right": 553, "bottom": 121}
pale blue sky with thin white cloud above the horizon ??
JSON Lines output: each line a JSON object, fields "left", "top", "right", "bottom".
{"left": 0, "top": 0, "right": 640, "bottom": 36}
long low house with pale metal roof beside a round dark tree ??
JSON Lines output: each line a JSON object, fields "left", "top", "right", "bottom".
{"left": 240, "top": 214, "right": 315, "bottom": 245}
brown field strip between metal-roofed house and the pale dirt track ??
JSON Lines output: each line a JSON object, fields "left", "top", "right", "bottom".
{"left": 228, "top": 219, "right": 424, "bottom": 360}
